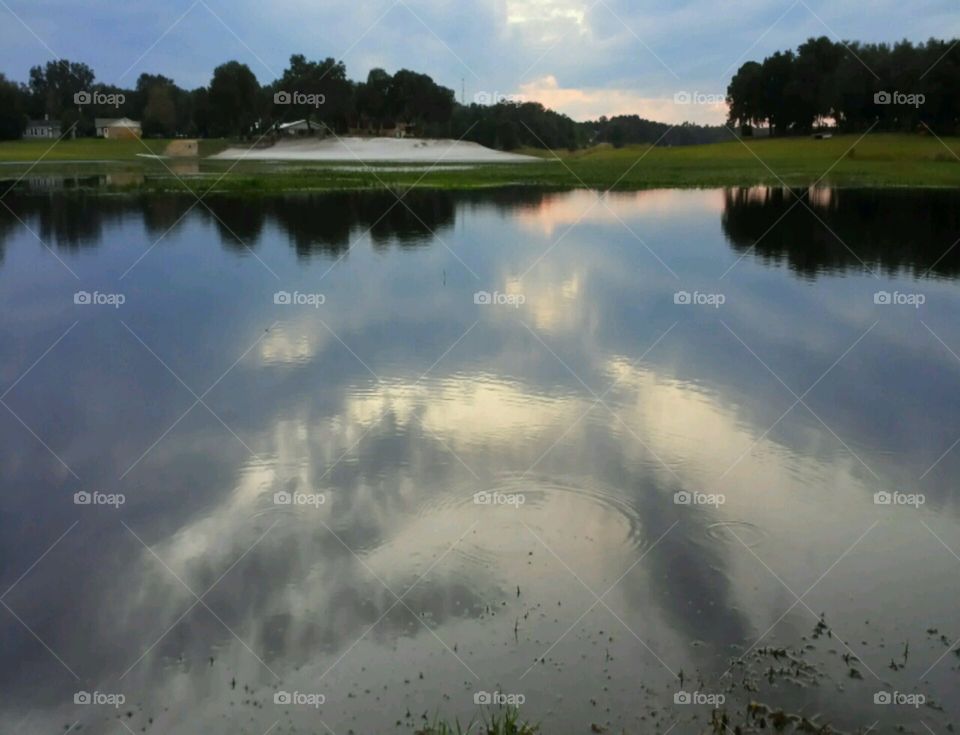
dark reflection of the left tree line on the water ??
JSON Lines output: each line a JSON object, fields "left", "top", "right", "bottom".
{"left": 0, "top": 187, "right": 546, "bottom": 257}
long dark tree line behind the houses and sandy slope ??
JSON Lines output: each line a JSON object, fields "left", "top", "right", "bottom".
{"left": 0, "top": 54, "right": 585, "bottom": 150}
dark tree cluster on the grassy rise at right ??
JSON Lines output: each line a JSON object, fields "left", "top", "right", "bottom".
{"left": 727, "top": 36, "right": 960, "bottom": 135}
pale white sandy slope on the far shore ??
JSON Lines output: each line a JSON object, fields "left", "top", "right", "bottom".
{"left": 212, "top": 138, "right": 539, "bottom": 163}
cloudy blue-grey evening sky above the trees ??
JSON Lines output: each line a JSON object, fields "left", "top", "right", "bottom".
{"left": 0, "top": 0, "right": 960, "bottom": 123}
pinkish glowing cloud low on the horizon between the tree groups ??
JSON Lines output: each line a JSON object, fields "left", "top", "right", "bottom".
{"left": 519, "top": 75, "right": 727, "bottom": 125}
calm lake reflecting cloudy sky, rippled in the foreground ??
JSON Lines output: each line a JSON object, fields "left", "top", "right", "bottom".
{"left": 0, "top": 185, "right": 960, "bottom": 735}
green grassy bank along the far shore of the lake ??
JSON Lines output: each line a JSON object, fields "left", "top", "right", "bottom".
{"left": 0, "top": 134, "right": 960, "bottom": 194}
